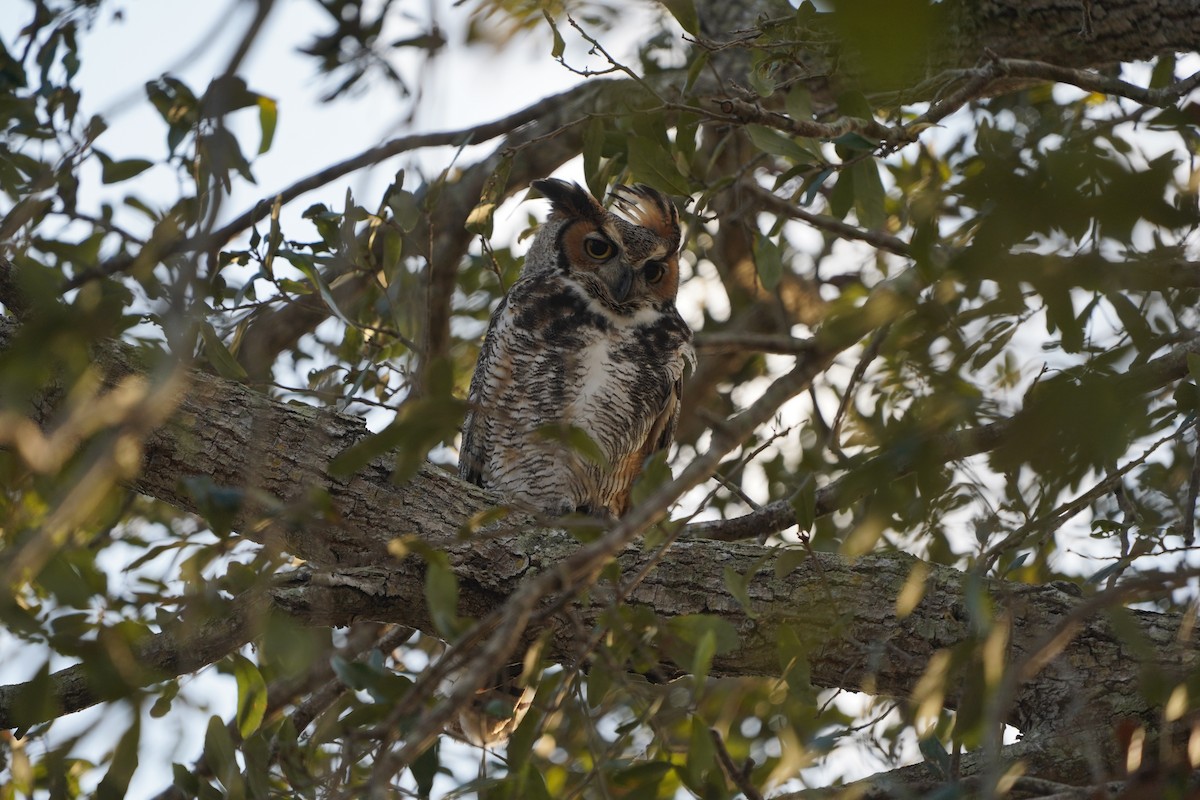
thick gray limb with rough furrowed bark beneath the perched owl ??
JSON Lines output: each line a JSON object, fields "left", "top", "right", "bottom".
{"left": 0, "top": 320, "right": 1200, "bottom": 782}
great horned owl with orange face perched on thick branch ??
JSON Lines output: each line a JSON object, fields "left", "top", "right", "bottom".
{"left": 458, "top": 179, "right": 692, "bottom": 517}
